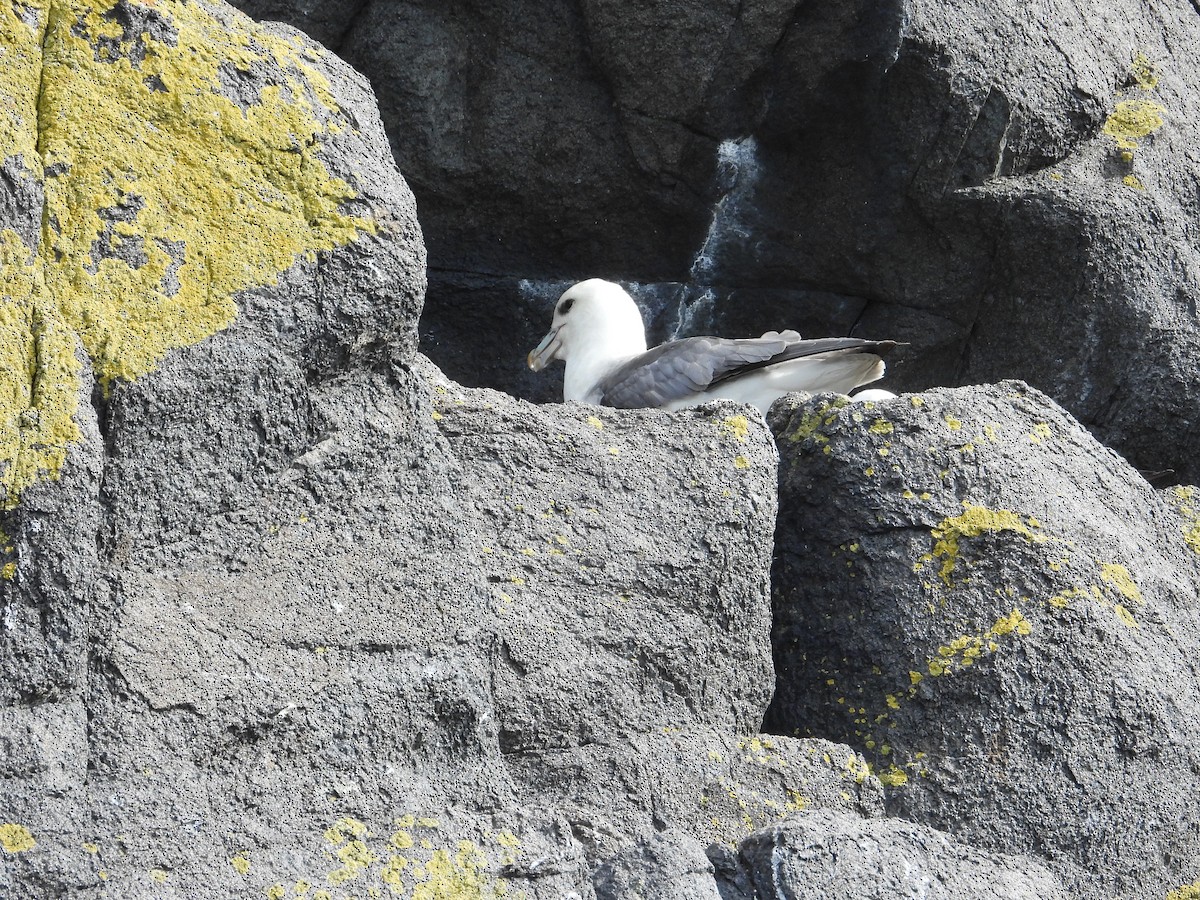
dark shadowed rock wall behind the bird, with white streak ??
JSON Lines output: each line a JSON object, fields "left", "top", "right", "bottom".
{"left": 226, "top": 0, "right": 1200, "bottom": 481}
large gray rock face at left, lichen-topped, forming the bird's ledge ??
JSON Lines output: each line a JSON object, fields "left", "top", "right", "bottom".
{"left": 0, "top": 1, "right": 882, "bottom": 900}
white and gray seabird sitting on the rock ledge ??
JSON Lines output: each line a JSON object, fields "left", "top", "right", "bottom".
{"left": 527, "top": 278, "right": 896, "bottom": 415}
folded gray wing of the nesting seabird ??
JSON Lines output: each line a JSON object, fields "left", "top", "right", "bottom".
{"left": 598, "top": 331, "right": 895, "bottom": 409}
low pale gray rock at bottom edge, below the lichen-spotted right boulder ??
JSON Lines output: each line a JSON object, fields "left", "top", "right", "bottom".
{"left": 742, "top": 810, "right": 1068, "bottom": 900}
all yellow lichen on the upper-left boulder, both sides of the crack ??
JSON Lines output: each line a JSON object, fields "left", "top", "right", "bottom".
{"left": 0, "top": 0, "right": 374, "bottom": 506}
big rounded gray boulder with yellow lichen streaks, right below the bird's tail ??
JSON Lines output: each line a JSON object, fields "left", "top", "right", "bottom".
{"left": 768, "top": 382, "right": 1200, "bottom": 898}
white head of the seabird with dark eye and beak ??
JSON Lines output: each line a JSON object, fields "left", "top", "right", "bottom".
{"left": 528, "top": 278, "right": 646, "bottom": 380}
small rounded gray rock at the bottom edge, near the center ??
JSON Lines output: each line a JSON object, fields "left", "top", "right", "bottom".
{"left": 592, "top": 832, "right": 721, "bottom": 900}
